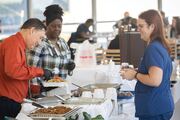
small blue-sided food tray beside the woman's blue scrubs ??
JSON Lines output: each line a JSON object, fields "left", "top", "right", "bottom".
{"left": 117, "top": 91, "right": 134, "bottom": 99}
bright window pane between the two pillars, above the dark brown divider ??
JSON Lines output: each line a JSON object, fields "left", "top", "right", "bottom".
{"left": 97, "top": 0, "right": 158, "bottom": 32}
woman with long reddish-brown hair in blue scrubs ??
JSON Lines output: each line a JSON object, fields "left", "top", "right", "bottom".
{"left": 121, "top": 10, "right": 174, "bottom": 120}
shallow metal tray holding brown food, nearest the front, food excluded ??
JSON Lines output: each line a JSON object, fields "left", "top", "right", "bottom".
{"left": 28, "top": 105, "right": 81, "bottom": 118}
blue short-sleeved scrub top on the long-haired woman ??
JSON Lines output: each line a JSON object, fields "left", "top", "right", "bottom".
{"left": 135, "top": 40, "right": 174, "bottom": 117}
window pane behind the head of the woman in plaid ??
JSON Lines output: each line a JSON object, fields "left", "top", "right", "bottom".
{"left": 32, "top": 0, "right": 92, "bottom": 32}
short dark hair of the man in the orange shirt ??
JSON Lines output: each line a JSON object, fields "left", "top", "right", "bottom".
{"left": 21, "top": 18, "right": 46, "bottom": 30}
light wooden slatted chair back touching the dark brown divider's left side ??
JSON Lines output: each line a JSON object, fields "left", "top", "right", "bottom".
{"left": 103, "top": 49, "right": 121, "bottom": 65}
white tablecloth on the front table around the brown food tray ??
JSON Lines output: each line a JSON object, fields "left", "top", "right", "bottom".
{"left": 17, "top": 99, "right": 114, "bottom": 120}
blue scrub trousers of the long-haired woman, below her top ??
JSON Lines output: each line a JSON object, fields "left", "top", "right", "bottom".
{"left": 139, "top": 112, "right": 173, "bottom": 120}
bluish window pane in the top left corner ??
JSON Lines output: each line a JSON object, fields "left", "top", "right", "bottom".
{"left": 0, "top": 0, "right": 27, "bottom": 39}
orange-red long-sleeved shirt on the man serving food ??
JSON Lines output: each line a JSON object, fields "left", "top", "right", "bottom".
{"left": 0, "top": 32, "right": 44, "bottom": 103}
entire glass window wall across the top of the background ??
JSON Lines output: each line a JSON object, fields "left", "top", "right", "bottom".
{"left": 0, "top": 0, "right": 179, "bottom": 39}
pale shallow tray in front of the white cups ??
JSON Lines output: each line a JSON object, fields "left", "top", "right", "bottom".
{"left": 64, "top": 97, "right": 106, "bottom": 105}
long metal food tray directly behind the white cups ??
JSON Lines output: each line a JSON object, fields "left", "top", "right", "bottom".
{"left": 79, "top": 83, "right": 121, "bottom": 92}
